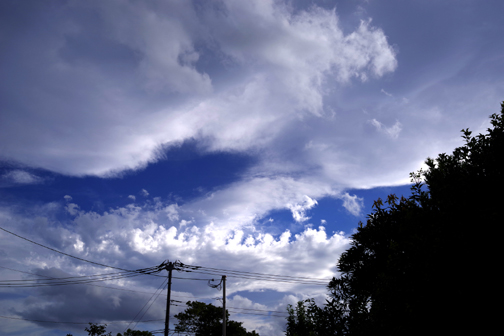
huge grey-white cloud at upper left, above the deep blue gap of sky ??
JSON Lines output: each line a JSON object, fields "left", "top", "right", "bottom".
{"left": 0, "top": 1, "right": 397, "bottom": 176}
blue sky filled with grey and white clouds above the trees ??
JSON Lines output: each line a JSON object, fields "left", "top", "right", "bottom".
{"left": 0, "top": 0, "right": 504, "bottom": 336}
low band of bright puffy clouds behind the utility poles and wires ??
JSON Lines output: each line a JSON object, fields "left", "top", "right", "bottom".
{"left": 0, "top": 199, "right": 349, "bottom": 335}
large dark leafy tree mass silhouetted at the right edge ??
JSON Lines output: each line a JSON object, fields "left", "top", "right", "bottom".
{"left": 286, "top": 102, "right": 504, "bottom": 336}
